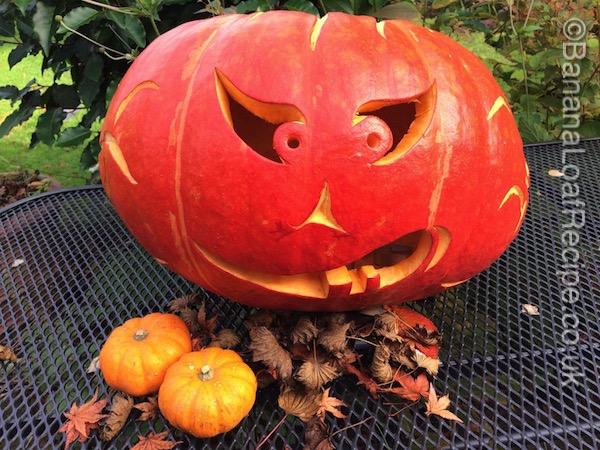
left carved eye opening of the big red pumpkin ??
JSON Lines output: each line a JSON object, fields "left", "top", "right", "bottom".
{"left": 215, "top": 69, "right": 305, "bottom": 164}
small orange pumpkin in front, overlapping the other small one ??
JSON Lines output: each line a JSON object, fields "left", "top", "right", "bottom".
{"left": 158, "top": 347, "right": 258, "bottom": 438}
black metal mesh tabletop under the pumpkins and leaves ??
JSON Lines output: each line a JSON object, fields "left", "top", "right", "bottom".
{"left": 0, "top": 140, "right": 600, "bottom": 450}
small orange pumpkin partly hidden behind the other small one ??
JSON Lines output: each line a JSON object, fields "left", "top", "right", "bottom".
{"left": 100, "top": 313, "right": 192, "bottom": 397}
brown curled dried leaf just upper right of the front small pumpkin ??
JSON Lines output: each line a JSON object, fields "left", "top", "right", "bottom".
{"left": 248, "top": 327, "right": 293, "bottom": 380}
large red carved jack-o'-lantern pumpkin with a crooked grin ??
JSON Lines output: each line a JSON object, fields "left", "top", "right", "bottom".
{"left": 99, "top": 11, "right": 529, "bottom": 311}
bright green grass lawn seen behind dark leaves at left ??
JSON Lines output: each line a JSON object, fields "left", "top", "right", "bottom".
{"left": 0, "top": 44, "right": 90, "bottom": 187}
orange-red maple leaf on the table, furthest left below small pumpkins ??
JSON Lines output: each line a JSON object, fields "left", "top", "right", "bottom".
{"left": 58, "top": 389, "right": 108, "bottom": 450}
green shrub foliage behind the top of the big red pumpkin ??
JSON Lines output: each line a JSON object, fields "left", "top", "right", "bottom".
{"left": 0, "top": 0, "right": 600, "bottom": 174}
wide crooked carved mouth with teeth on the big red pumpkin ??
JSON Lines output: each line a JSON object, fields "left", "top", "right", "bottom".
{"left": 194, "top": 226, "right": 451, "bottom": 299}
